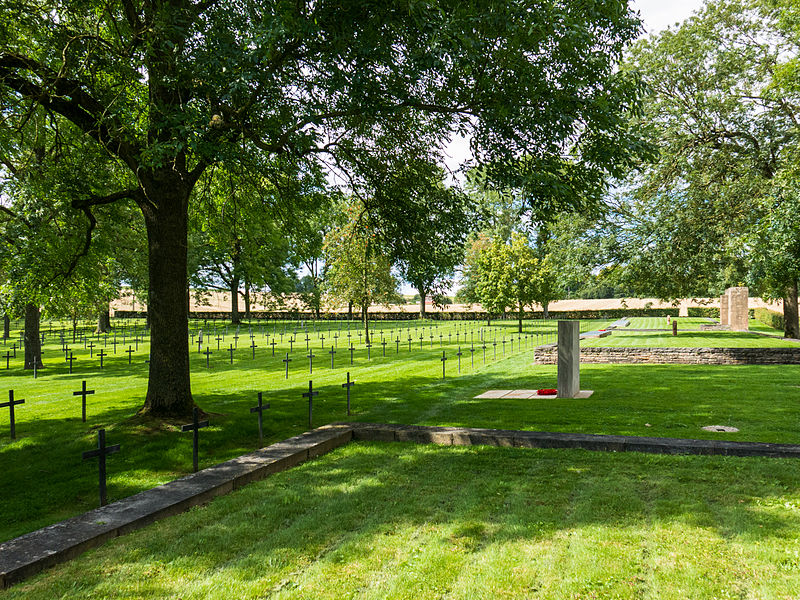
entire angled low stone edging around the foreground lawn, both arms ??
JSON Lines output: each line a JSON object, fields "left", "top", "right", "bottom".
{"left": 6, "top": 423, "right": 800, "bottom": 589}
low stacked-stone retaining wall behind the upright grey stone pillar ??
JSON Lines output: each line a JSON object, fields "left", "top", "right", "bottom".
{"left": 534, "top": 346, "right": 800, "bottom": 365}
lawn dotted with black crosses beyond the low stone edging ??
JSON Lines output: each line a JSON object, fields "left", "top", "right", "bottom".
{"left": 0, "top": 323, "right": 800, "bottom": 540}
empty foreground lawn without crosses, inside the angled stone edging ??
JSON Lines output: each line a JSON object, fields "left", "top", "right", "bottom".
{"left": 5, "top": 443, "right": 800, "bottom": 600}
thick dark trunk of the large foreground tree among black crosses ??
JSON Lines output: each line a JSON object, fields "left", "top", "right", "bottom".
{"left": 140, "top": 177, "right": 194, "bottom": 417}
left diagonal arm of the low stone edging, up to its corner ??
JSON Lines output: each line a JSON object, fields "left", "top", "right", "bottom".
{"left": 0, "top": 424, "right": 353, "bottom": 589}
